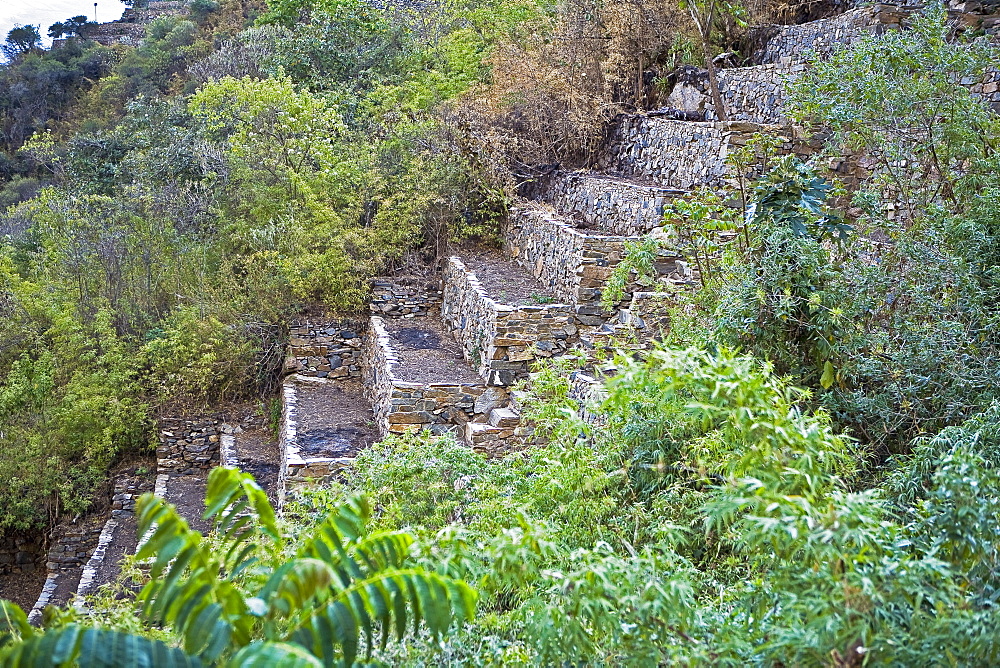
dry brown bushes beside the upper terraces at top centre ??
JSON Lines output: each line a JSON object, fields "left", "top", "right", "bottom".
{"left": 447, "top": 0, "right": 843, "bottom": 191}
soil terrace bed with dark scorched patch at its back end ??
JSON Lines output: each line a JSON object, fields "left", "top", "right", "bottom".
{"left": 386, "top": 313, "right": 483, "bottom": 385}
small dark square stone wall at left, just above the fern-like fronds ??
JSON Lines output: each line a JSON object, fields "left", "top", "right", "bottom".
{"left": 156, "top": 416, "right": 222, "bottom": 475}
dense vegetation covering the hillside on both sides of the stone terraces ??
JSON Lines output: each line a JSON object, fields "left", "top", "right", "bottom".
{"left": 0, "top": 0, "right": 1000, "bottom": 666}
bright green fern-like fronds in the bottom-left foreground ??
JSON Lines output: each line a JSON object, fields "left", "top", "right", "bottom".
{"left": 0, "top": 468, "right": 475, "bottom": 666}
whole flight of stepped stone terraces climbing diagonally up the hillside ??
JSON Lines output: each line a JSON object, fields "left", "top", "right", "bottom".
{"left": 23, "top": 4, "right": 1000, "bottom": 621}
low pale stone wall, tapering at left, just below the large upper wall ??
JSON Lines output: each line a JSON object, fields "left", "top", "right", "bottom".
{"left": 522, "top": 172, "right": 684, "bottom": 236}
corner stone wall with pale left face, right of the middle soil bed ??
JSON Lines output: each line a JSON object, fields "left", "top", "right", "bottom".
{"left": 441, "top": 257, "right": 579, "bottom": 386}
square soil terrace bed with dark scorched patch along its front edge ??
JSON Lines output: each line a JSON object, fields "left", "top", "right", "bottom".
{"left": 295, "top": 380, "right": 378, "bottom": 457}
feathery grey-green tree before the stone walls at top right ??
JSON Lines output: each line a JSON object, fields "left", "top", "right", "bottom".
{"left": 792, "top": 4, "right": 1000, "bottom": 220}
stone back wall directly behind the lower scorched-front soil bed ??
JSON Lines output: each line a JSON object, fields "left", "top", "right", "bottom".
{"left": 285, "top": 318, "right": 368, "bottom": 378}
